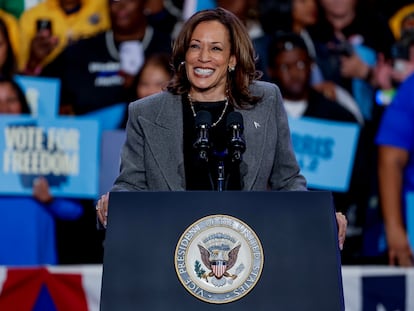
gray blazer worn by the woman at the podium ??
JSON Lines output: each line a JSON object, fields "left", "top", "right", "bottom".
{"left": 111, "top": 81, "right": 306, "bottom": 191}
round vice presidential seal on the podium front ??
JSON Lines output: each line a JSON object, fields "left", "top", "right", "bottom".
{"left": 174, "top": 215, "right": 264, "bottom": 304}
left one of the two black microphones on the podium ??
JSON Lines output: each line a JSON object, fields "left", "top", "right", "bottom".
{"left": 193, "top": 110, "right": 212, "bottom": 162}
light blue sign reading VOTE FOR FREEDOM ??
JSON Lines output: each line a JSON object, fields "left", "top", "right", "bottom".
{"left": 0, "top": 116, "right": 99, "bottom": 198}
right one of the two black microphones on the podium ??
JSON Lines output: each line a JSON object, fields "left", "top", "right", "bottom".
{"left": 226, "top": 111, "right": 246, "bottom": 163}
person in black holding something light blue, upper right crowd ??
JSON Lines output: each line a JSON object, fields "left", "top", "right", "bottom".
{"left": 311, "top": 0, "right": 394, "bottom": 122}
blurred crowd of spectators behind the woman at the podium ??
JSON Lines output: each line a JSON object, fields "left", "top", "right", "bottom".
{"left": 0, "top": 0, "right": 414, "bottom": 266}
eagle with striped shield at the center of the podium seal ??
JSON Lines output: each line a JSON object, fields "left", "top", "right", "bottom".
{"left": 196, "top": 233, "right": 243, "bottom": 286}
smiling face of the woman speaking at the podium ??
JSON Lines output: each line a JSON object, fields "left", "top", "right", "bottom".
{"left": 185, "top": 21, "right": 236, "bottom": 100}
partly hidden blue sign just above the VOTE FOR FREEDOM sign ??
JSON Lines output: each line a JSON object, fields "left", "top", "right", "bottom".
{"left": 15, "top": 75, "right": 60, "bottom": 118}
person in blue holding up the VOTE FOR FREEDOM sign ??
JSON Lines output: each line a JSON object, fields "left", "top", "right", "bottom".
{"left": 0, "top": 77, "right": 83, "bottom": 266}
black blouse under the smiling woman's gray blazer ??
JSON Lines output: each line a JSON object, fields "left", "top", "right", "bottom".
{"left": 182, "top": 96, "right": 241, "bottom": 190}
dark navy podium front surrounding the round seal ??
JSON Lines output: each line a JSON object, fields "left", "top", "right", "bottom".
{"left": 100, "top": 191, "right": 345, "bottom": 311}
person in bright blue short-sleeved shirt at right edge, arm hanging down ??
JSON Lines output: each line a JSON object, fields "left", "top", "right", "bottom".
{"left": 376, "top": 74, "right": 414, "bottom": 267}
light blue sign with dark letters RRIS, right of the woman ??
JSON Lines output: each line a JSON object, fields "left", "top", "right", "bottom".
{"left": 289, "top": 117, "right": 360, "bottom": 192}
